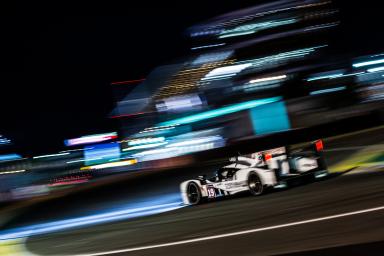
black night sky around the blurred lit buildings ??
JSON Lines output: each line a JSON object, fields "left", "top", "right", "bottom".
{"left": 0, "top": 0, "right": 384, "bottom": 154}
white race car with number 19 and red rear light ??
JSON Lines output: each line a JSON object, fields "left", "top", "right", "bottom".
{"left": 180, "top": 140, "right": 328, "bottom": 205}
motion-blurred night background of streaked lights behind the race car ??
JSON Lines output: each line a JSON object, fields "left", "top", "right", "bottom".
{"left": 0, "top": 0, "right": 384, "bottom": 254}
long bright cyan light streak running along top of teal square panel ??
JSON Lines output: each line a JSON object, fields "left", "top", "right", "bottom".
{"left": 160, "top": 97, "right": 281, "bottom": 126}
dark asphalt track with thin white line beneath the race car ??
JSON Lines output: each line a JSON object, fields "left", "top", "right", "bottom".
{"left": 4, "top": 127, "right": 384, "bottom": 256}
